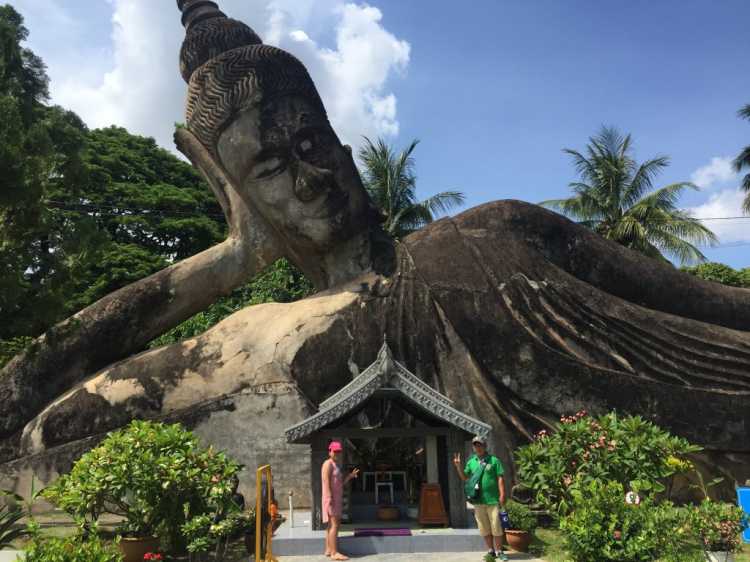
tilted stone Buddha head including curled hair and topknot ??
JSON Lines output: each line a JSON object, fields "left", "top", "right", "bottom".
{"left": 177, "top": 0, "right": 388, "bottom": 284}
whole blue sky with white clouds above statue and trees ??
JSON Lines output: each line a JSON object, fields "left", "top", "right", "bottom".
{"left": 12, "top": 0, "right": 750, "bottom": 268}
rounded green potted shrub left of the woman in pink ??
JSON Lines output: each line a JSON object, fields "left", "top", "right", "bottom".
{"left": 43, "top": 421, "right": 243, "bottom": 537}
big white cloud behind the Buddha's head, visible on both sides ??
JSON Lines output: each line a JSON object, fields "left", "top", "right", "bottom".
{"left": 17, "top": 0, "right": 410, "bottom": 155}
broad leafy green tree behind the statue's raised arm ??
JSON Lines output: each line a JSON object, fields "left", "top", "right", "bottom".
{"left": 53, "top": 127, "right": 226, "bottom": 315}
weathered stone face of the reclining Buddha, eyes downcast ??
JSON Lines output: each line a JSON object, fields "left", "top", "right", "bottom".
{"left": 217, "top": 96, "right": 370, "bottom": 251}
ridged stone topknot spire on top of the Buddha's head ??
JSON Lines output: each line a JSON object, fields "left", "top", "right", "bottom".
{"left": 177, "top": 0, "right": 263, "bottom": 82}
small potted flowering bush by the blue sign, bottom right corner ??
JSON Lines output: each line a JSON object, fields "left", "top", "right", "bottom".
{"left": 686, "top": 498, "right": 748, "bottom": 552}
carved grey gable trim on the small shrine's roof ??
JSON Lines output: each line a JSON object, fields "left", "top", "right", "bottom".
{"left": 284, "top": 336, "right": 492, "bottom": 443}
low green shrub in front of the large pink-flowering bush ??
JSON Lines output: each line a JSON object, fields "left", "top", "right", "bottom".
{"left": 560, "top": 481, "right": 684, "bottom": 562}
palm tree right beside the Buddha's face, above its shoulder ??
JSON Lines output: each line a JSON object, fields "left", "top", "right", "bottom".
{"left": 359, "top": 137, "right": 464, "bottom": 240}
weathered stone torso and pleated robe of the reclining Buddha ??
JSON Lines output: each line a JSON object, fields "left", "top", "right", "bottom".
{"left": 0, "top": 201, "right": 750, "bottom": 489}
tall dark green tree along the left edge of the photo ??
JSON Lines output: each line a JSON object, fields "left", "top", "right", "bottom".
{"left": 0, "top": 5, "right": 94, "bottom": 346}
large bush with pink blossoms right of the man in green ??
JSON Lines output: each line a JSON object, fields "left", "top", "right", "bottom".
{"left": 516, "top": 411, "right": 701, "bottom": 515}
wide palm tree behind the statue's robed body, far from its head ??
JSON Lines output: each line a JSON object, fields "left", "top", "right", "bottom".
{"left": 539, "top": 126, "right": 716, "bottom": 264}
